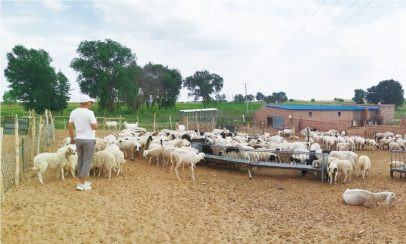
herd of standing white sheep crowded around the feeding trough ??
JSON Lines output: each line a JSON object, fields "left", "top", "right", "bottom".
{"left": 29, "top": 123, "right": 406, "bottom": 207}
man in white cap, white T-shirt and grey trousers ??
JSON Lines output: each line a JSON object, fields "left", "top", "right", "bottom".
{"left": 68, "top": 95, "right": 97, "bottom": 191}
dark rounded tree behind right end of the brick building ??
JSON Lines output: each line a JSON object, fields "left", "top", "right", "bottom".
{"left": 366, "top": 80, "right": 404, "bottom": 107}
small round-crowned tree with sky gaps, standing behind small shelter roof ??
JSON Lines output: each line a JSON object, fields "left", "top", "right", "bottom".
{"left": 183, "top": 70, "right": 223, "bottom": 106}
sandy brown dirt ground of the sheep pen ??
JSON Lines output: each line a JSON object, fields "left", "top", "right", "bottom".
{"left": 1, "top": 132, "right": 406, "bottom": 243}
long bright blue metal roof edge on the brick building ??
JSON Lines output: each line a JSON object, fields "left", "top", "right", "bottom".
{"left": 266, "top": 104, "right": 379, "bottom": 111}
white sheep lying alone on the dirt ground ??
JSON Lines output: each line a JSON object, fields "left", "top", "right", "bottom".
{"left": 343, "top": 189, "right": 396, "bottom": 208}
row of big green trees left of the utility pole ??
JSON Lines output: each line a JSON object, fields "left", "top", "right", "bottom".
{"left": 3, "top": 39, "right": 225, "bottom": 112}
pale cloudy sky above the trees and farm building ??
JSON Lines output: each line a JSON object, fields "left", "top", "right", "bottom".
{"left": 0, "top": 0, "right": 406, "bottom": 101}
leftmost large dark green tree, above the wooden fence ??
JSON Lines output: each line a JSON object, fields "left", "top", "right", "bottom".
{"left": 4, "top": 45, "right": 70, "bottom": 113}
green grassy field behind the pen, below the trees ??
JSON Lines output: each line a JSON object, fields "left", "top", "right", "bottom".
{"left": 1, "top": 100, "right": 406, "bottom": 128}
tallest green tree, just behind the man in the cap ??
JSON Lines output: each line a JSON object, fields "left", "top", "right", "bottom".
{"left": 71, "top": 39, "right": 139, "bottom": 112}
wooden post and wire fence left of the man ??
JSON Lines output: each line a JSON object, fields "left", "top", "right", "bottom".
{"left": 0, "top": 110, "right": 55, "bottom": 199}
